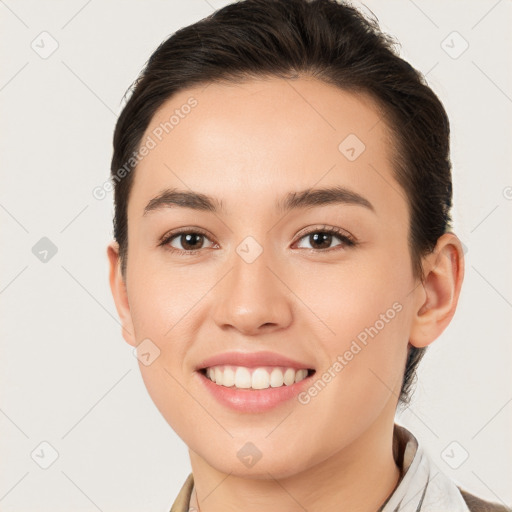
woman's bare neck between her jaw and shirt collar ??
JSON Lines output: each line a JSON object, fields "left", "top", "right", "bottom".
{"left": 189, "top": 411, "right": 400, "bottom": 512}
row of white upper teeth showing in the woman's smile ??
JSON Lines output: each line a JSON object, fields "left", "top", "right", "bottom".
{"left": 206, "top": 366, "right": 308, "bottom": 389}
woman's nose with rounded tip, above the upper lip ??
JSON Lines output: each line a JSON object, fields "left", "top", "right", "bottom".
{"left": 213, "top": 247, "right": 293, "bottom": 335}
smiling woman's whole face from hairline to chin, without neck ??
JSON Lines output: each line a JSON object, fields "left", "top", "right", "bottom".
{"left": 110, "top": 78, "right": 422, "bottom": 478}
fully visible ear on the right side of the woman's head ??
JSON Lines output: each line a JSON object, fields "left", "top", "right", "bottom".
{"left": 409, "top": 233, "right": 464, "bottom": 348}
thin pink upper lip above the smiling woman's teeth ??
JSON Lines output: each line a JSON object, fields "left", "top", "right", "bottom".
{"left": 196, "top": 351, "right": 313, "bottom": 370}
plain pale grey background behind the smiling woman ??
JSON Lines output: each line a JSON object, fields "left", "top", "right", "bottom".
{"left": 0, "top": 0, "right": 512, "bottom": 512}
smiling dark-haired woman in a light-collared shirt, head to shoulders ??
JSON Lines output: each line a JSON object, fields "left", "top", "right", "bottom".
{"left": 108, "top": 0, "right": 506, "bottom": 512}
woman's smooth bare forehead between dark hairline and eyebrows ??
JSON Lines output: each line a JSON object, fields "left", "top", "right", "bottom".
{"left": 129, "top": 78, "right": 399, "bottom": 217}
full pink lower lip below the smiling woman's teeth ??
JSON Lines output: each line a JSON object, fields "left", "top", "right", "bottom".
{"left": 197, "top": 372, "right": 314, "bottom": 412}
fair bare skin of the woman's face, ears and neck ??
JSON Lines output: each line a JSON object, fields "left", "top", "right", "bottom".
{"left": 108, "top": 77, "right": 464, "bottom": 512}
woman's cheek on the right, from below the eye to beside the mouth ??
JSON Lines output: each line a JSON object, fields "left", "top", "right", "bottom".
{"left": 297, "top": 252, "right": 412, "bottom": 400}
